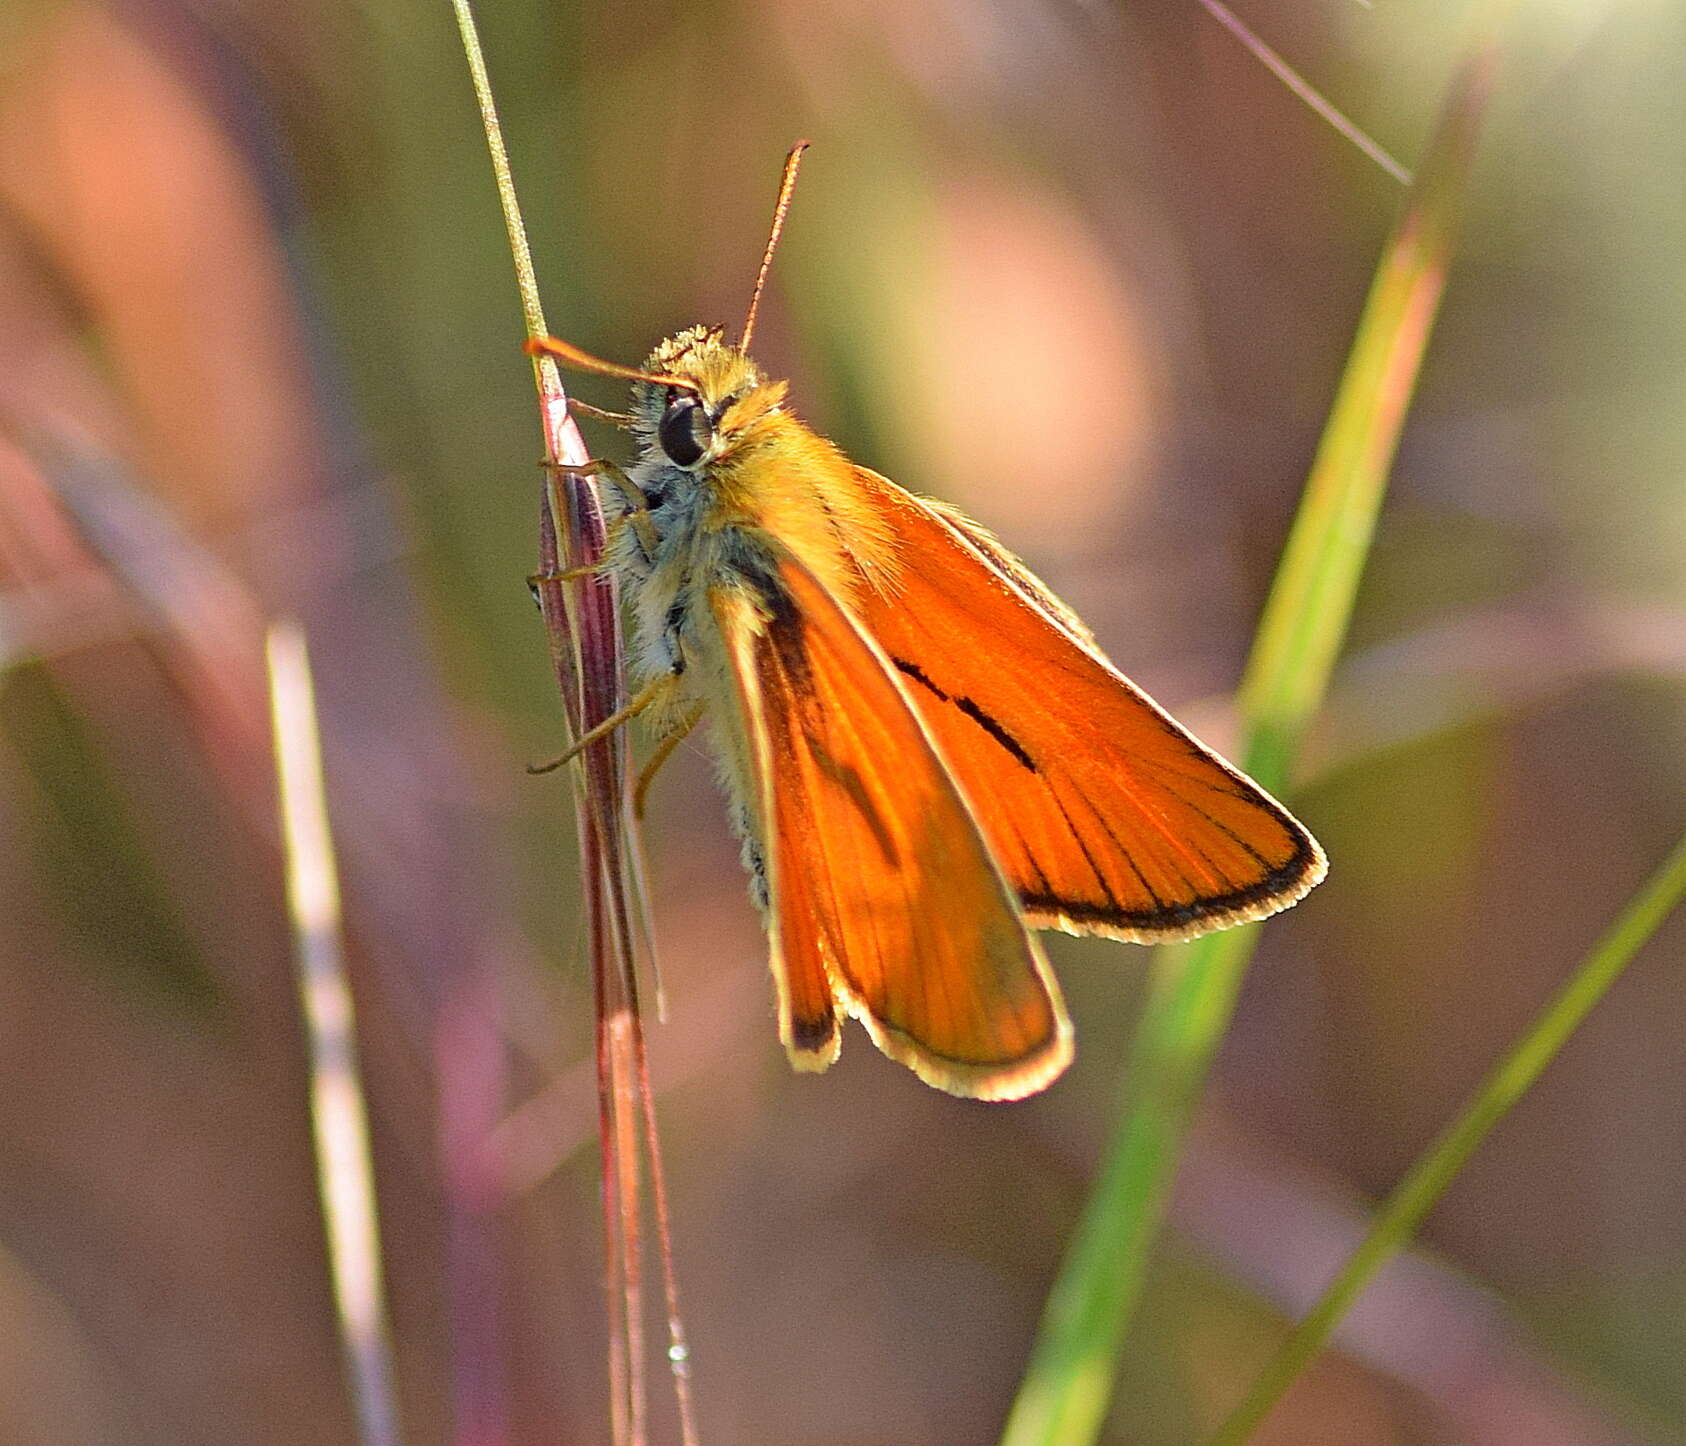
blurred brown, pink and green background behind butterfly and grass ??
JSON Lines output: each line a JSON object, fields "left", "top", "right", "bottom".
{"left": 0, "top": 0, "right": 1686, "bottom": 1446}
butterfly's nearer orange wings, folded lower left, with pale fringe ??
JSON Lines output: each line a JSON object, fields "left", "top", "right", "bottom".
{"left": 710, "top": 558, "right": 1071, "bottom": 1099}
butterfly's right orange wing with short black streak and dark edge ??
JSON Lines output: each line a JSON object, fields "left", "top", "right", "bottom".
{"left": 855, "top": 469, "right": 1325, "bottom": 942}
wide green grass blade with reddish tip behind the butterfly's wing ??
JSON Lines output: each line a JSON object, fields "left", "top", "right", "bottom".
{"left": 1001, "top": 47, "right": 1492, "bottom": 1446}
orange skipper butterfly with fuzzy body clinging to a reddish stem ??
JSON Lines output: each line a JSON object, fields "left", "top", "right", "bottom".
{"left": 529, "top": 147, "right": 1325, "bottom": 1099}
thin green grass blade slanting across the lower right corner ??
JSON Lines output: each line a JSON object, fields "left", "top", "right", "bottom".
{"left": 1211, "top": 822, "right": 1686, "bottom": 1446}
